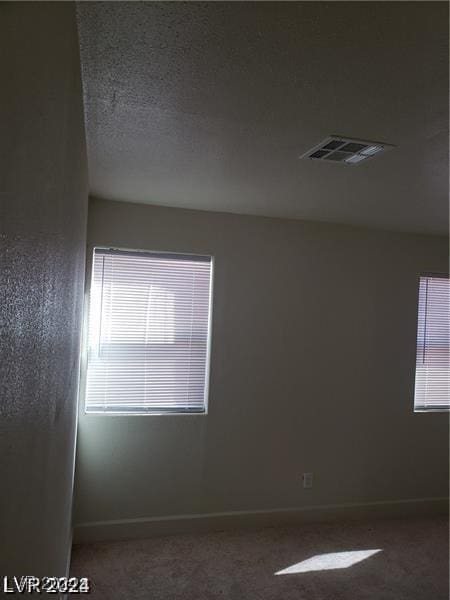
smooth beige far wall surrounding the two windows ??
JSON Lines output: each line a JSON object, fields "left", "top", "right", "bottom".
{"left": 76, "top": 200, "right": 448, "bottom": 523}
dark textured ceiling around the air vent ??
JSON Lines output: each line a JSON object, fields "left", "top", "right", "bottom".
{"left": 78, "top": 2, "right": 448, "bottom": 233}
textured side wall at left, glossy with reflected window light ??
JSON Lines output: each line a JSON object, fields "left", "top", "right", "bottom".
{"left": 0, "top": 2, "right": 88, "bottom": 576}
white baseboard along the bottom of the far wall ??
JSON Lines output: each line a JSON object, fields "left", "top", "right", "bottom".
{"left": 74, "top": 498, "right": 449, "bottom": 543}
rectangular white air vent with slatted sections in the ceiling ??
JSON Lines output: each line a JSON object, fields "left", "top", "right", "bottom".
{"left": 299, "top": 135, "right": 395, "bottom": 166}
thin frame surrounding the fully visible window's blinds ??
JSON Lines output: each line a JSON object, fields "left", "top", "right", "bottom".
{"left": 78, "top": 244, "right": 215, "bottom": 418}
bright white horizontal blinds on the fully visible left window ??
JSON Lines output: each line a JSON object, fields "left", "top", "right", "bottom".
{"left": 86, "top": 249, "right": 211, "bottom": 413}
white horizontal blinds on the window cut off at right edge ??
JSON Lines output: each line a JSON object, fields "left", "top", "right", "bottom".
{"left": 414, "top": 276, "right": 450, "bottom": 410}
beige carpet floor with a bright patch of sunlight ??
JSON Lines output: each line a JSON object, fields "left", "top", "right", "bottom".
{"left": 72, "top": 518, "right": 449, "bottom": 600}
